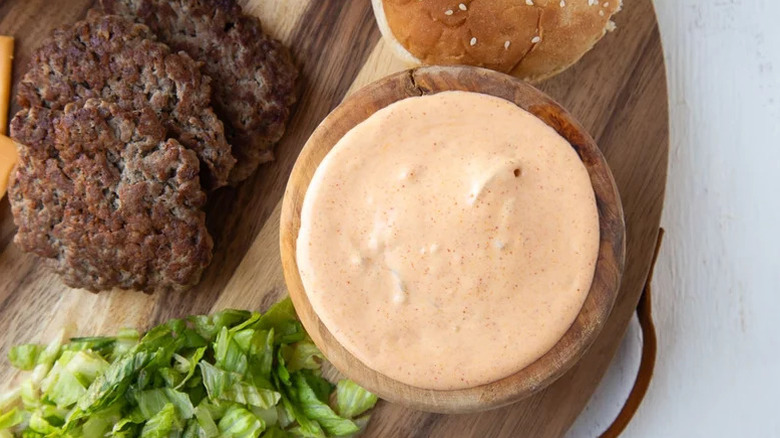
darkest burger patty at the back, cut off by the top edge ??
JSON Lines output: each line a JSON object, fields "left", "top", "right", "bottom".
{"left": 100, "top": 0, "right": 297, "bottom": 183}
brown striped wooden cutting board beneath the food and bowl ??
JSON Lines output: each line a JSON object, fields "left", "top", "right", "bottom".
{"left": 0, "top": 0, "right": 669, "bottom": 437}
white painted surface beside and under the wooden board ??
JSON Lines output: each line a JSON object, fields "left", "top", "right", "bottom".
{"left": 568, "top": 0, "right": 780, "bottom": 438}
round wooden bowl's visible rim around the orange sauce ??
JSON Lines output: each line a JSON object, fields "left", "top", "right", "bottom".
{"left": 280, "top": 67, "right": 625, "bottom": 413}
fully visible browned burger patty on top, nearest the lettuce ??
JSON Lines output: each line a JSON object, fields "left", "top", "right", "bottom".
{"left": 8, "top": 99, "right": 212, "bottom": 292}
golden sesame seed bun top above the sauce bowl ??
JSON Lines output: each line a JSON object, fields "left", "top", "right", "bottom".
{"left": 374, "top": 0, "right": 621, "bottom": 80}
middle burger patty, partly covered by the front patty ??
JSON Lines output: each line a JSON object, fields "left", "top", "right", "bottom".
{"left": 17, "top": 12, "right": 235, "bottom": 189}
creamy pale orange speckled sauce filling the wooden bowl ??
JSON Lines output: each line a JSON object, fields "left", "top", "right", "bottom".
{"left": 296, "top": 91, "right": 599, "bottom": 389}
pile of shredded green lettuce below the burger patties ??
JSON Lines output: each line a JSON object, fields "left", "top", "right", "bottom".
{"left": 0, "top": 299, "right": 377, "bottom": 438}
